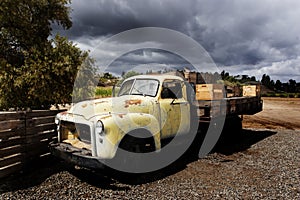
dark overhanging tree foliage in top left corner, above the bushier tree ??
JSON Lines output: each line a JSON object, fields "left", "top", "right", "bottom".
{"left": 0, "top": 0, "right": 72, "bottom": 66}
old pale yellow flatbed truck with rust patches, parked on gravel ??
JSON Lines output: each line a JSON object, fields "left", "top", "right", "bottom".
{"left": 50, "top": 75, "right": 262, "bottom": 172}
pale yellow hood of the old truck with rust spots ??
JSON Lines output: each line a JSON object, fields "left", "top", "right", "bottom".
{"left": 63, "top": 95, "right": 154, "bottom": 120}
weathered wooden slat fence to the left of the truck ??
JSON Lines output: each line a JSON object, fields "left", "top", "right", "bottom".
{"left": 0, "top": 110, "right": 61, "bottom": 178}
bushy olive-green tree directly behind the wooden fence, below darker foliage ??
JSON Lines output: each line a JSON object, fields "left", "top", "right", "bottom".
{"left": 0, "top": 36, "right": 94, "bottom": 109}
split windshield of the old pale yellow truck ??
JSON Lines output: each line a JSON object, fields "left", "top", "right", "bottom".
{"left": 118, "top": 79, "right": 159, "bottom": 97}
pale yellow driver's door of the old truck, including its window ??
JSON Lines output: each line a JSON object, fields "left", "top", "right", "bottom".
{"left": 160, "top": 80, "right": 190, "bottom": 138}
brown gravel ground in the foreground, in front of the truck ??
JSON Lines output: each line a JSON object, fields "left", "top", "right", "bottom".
{"left": 0, "top": 129, "right": 300, "bottom": 199}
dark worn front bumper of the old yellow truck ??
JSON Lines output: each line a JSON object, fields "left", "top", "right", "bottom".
{"left": 49, "top": 142, "right": 105, "bottom": 169}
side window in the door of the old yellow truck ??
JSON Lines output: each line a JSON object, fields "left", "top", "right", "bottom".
{"left": 161, "top": 80, "right": 182, "bottom": 99}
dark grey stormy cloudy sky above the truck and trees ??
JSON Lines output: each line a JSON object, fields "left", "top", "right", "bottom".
{"left": 54, "top": 0, "right": 300, "bottom": 82}
